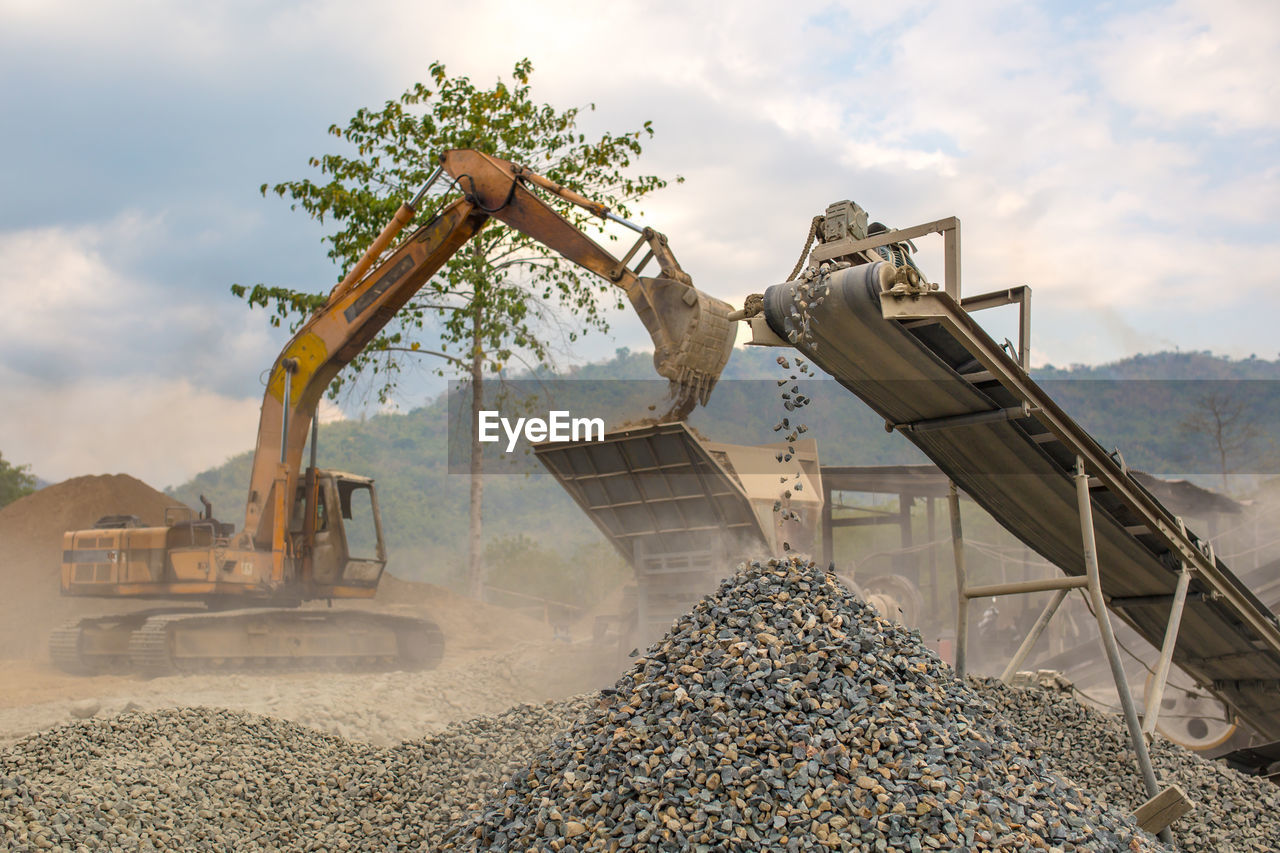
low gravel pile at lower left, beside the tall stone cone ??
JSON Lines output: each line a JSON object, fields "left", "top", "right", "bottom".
{"left": 0, "top": 698, "right": 595, "bottom": 850}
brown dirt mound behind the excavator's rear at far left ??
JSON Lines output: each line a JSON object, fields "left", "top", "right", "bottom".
{"left": 0, "top": 474, "right": 182, "bottom": 658}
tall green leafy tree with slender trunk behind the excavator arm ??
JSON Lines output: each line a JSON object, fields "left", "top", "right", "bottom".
{"left": 232, "top": 59, "right": 678, "bottom": 594}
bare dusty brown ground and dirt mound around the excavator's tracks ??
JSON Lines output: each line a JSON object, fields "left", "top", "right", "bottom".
{"left": 0, "top": 474, "right": 637, "bottom": 744}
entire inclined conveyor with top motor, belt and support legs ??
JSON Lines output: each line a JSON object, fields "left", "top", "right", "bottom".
{"left": 736, "top": 194, "right": 1280, "bottom": 797}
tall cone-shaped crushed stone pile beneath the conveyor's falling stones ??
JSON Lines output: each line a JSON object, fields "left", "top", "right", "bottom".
{"left": 445, "top": 560, "right": 1165, "bottom": 853}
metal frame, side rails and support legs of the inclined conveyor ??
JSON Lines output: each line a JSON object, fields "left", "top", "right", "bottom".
{"left": 750, "top": 212, "right": 1280, "bottom": 840}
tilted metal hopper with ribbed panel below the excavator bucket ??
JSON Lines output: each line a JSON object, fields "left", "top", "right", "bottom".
{"left": 534, "top": 423, "right": 822, "bottom": 642}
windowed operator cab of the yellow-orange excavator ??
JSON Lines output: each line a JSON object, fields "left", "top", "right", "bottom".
{"left": 291, "top": 470, "right": 387, "bottom": 589}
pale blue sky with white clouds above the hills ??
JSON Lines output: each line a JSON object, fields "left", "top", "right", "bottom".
{"left": 0, "top": 0, "right": 1280, "bottom": 487}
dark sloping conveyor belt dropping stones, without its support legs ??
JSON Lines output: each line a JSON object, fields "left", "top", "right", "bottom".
{"left": 764, "top": 264, "right": 1280, "bottom": 740}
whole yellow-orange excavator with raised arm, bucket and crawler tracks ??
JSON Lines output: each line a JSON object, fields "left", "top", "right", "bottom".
{"left": 50, "top": 150, "right": 735, "bottom": 676}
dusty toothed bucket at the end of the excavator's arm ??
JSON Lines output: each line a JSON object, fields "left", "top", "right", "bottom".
{"left": 627, "top": 278, "right": 737, "bottom": 420}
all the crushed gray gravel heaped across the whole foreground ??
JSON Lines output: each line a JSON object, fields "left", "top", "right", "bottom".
{"left": 10, "top": 561, "right": 1280, "bottom": 853}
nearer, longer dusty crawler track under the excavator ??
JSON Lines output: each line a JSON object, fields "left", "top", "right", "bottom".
{"left": 129, "top": 610, "right": 444, "bottom": 678}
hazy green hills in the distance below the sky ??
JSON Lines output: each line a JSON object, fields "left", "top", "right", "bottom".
{"left": 170, "top": 348, "right": 1280, "bottom": 602}
